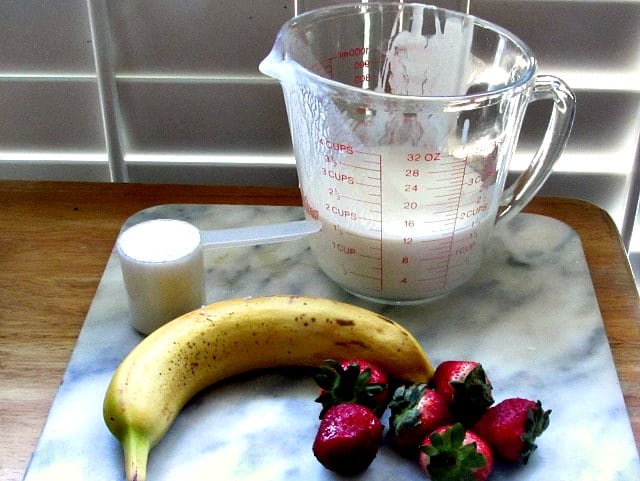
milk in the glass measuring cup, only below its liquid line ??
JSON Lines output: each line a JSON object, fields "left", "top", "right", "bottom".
{"left": 312, "top": 213, "right": 493, "bottom": 302}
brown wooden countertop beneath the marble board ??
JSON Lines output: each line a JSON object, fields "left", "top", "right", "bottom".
{"left": 0, "top": 181, "right": 640, "bottom": 480}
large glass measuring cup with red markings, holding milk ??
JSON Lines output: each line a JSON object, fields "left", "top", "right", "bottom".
{"left": 260, "top": 2, "right": 575, "bottom": 304}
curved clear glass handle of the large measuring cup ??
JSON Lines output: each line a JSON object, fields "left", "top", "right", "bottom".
{"left": 496, "top": 75, "right": 576, "bottom": 222}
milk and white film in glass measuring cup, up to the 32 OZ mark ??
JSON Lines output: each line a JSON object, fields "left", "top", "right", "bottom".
{"left": 303, "top": 142, "right": 496, "bottom": 303}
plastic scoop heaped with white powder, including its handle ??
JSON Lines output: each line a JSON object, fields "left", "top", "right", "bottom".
{"left": 116, "top": 219, "right": 321, "bottom": 334}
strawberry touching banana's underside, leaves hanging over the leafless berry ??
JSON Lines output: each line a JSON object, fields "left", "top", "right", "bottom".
{"left": 314, "top": 359, "right": 389, "bottom": 417}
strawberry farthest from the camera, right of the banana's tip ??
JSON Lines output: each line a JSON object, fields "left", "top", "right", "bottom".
{"left": 433, "top": 361, "right": 493, "bottom": 426}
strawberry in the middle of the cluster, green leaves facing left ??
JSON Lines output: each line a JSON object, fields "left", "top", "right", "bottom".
{"left": 389, "top": 384, "right": 453, "bottom": 454}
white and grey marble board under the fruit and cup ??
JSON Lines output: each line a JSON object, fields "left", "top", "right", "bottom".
{"left": 24, "top": 205, "right": 640, "bottom": 481}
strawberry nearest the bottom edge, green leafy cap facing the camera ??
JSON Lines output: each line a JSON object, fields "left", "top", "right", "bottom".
{"left": 419, "top": 423, "right": 493, "bottom": 481}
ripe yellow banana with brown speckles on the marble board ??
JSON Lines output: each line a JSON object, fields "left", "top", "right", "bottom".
{"left": 103, "top": 296, "right": 433, "bottom": 481}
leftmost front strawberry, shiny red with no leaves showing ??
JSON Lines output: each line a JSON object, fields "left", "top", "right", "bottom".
{"left": 313, "top": 403, "right": 384, "bottom": 475}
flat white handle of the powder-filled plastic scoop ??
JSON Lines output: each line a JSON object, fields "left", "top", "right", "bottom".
{"left": 200, "top": 219, "right": 322, "bottom": 248}
